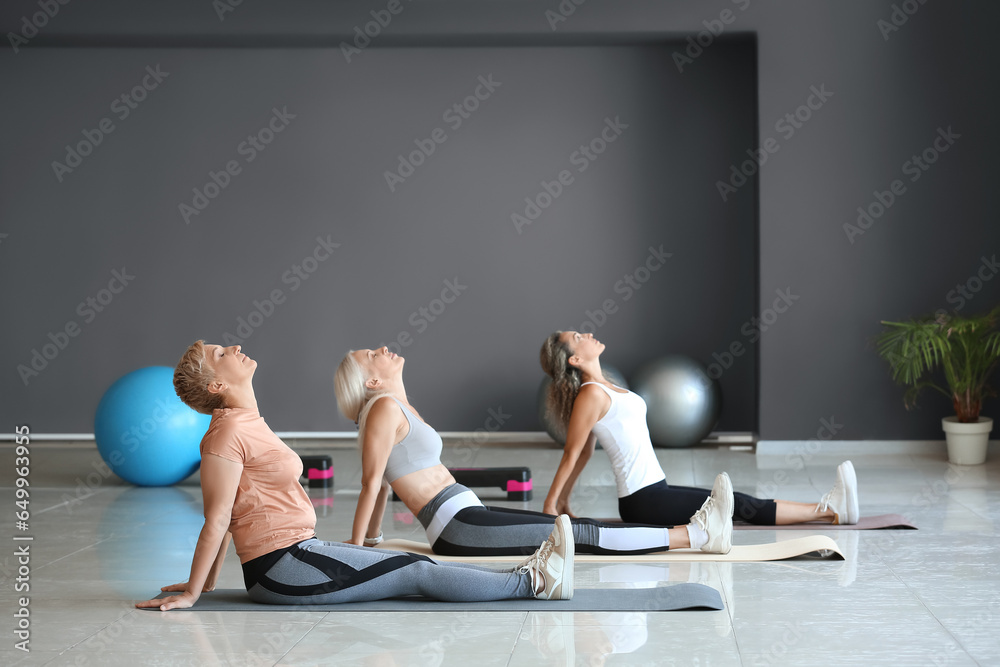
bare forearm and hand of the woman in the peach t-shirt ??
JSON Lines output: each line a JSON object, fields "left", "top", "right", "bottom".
{"left": 136, "top": 454, "right": 243, "bottom": 611}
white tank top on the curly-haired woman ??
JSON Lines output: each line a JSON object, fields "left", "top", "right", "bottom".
{"left": 580, "top": 382, "right": 666, "bottom": 498}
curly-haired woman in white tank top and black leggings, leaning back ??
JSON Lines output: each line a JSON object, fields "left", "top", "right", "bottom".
{"left": 540, "top": 331, "right": 858, "bottom": 526}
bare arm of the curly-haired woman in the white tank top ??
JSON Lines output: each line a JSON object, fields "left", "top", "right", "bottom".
{"left": 544, "top": 386, "right": 611, "bottom": 514}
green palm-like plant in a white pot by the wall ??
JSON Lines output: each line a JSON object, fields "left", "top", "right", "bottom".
{"left": 875, "top": 306, "right": 1000, "bottom": 465}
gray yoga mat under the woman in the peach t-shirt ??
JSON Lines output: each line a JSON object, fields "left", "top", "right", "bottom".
{"left": 143, "top": 584, "right": 725, "bottom": 612}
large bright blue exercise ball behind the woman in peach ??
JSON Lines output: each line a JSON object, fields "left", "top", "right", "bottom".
{"left": 94, "top": 366, "right": 212, "bottom": 486}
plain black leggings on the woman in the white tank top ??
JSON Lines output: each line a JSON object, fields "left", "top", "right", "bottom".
{"left": 618, "top": 480, "right": 778, "bottom": 526}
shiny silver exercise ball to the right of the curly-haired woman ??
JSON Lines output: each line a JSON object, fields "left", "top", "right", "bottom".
{"left": 635, "top": 355, "right": 722, "bottom": 447}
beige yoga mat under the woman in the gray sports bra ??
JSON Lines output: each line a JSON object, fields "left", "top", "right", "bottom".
{"left": 378, "top": 535, "right": 845, "bottom": 563}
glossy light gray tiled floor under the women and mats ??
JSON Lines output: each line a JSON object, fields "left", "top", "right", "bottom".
{"left": 0, "top": 444, "right": 1000, "bottom": 667}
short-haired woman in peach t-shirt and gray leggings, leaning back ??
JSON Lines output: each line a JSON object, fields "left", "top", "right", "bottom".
{"left": 136, "top": 341, "right": 573, "bottom": 611}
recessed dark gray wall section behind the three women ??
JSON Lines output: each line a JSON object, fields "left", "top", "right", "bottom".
{"left": 2, "top": 27, "right": 756, "bottom": 432}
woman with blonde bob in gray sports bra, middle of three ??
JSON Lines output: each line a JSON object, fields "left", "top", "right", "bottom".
{"left": 334, "top": 347, "right": 732, "bottom": 556}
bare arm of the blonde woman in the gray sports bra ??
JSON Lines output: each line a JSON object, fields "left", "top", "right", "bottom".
{"left": 350, "top": 399, "right": 398, "bottom": 545}
